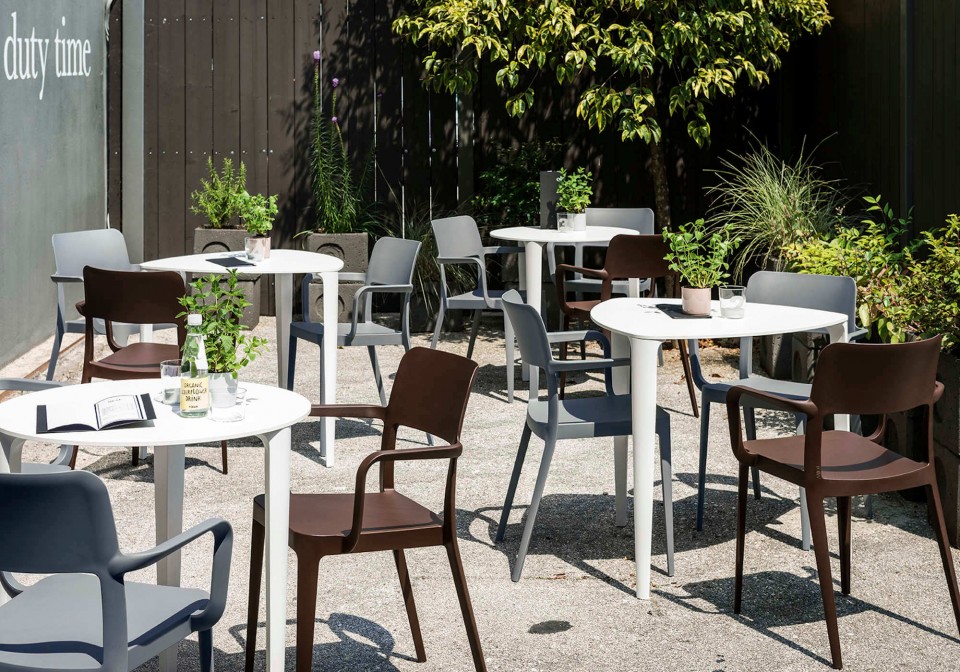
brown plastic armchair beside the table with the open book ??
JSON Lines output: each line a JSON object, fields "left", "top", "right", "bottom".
{"left": 246, "top": 348, "right": 487, "bottom": 672}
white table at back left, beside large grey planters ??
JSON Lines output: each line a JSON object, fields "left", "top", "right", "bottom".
{"left": 139, "top": 250, "right": 343, "bottom": 467}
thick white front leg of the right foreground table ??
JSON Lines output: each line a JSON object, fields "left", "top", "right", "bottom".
{"left": 630, "top": 339, "right": 660, "bottom": 600}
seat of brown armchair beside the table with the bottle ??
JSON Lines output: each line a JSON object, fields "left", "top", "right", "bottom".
{"left": 253, "top": 491, "right": 443, "bottom": 555}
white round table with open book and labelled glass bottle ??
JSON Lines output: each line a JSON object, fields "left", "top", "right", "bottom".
{"left": 0, "top": 379, "right": 310, "bottom": 670}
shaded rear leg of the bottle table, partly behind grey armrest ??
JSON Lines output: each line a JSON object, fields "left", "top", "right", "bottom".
{"left": 153, "top": 446, "right": 185, "bottom": 672}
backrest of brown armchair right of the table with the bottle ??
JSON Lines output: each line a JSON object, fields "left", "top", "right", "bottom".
{"left": 383, "top": 348, "right": 478, "bottom": 449}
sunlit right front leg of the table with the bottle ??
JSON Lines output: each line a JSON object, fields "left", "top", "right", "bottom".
{"left": 260, "top": 430, "right": 290, "bottom": 672}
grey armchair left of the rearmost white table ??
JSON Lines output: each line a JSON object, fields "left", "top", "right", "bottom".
{"left": 431, "top": 215, "right": 527, "bottom": 402}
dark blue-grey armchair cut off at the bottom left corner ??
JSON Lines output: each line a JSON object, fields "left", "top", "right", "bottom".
{"left": 0, "top": 471, "right": 233, "bottom": 672}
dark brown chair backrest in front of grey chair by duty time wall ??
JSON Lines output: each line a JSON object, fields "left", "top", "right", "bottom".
{"left": 83, "top": 266, "right": 186, "bottom": 345}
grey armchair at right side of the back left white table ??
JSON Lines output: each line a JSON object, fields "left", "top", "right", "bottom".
{"left": 287, "top": 238, "right": 420, "bottom": 405}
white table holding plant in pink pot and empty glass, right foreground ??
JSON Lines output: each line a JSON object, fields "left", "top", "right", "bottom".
{"left": 590, "top": 298, "right": 849, "bottom": 599}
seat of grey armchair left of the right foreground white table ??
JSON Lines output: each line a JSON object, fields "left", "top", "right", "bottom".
{"left": 527, "top": 394, "right": 670, "bottom": 440}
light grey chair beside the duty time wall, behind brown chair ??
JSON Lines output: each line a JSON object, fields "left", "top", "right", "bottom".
{"left": 47, "top": 229, "right": 174, "bottom": 380}
